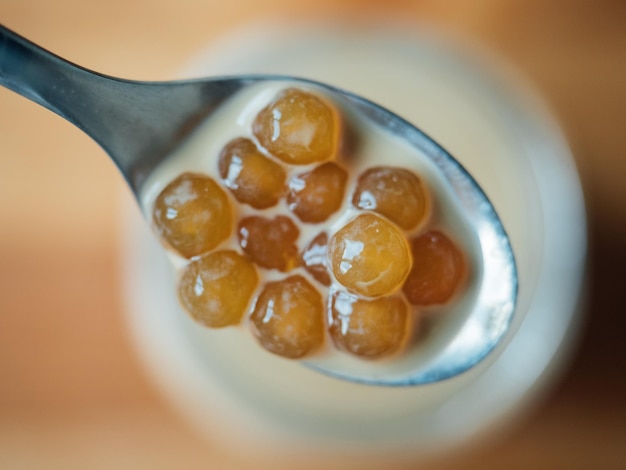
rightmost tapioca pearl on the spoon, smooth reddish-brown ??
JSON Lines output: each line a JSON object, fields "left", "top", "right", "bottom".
{"left": 402, "top": 231, "right": 465, "bottom": 305}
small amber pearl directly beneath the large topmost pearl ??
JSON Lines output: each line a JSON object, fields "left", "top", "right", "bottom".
{"left": 287, "top": 162, "right": 348, "bottom": 223}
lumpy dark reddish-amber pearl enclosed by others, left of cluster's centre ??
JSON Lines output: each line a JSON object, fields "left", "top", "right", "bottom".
{"left": 237, "top": 215, "right": 300, "bottom": 272}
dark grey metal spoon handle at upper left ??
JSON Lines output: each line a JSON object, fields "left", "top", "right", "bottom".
{"left": 0, "top": 25, "right": 234, "bottom": 194}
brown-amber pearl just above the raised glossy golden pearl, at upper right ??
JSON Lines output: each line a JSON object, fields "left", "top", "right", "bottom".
{"left": 352, "top": 167, "right": 429, "bottom": 230}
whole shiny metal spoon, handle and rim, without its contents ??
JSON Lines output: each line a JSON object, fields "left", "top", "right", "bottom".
{"left": 0, "top": 26, "right": 517, "bottom": 386}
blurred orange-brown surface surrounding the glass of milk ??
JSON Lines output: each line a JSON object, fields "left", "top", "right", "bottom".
{"left": 0, "top": 0, "right": 626, "bottom": 469}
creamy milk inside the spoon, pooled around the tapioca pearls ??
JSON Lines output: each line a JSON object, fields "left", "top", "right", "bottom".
{"left": 141, "top": 82, "right": 481, "bottom": 379}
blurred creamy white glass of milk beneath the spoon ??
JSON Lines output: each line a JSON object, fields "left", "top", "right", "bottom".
{"left": 125, "top": 25, "right": 585, "bottom": 456}
